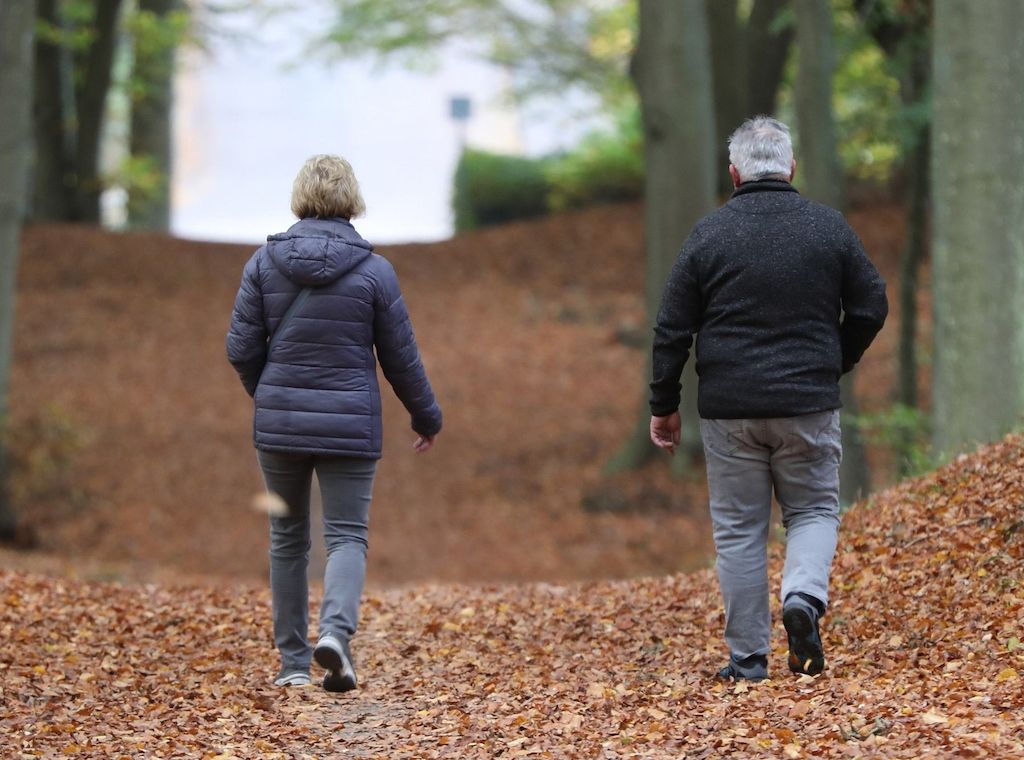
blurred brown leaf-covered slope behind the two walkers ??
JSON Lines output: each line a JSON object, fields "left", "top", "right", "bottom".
{"left": 2, "top": 199, "right": 913, "bottom": 587}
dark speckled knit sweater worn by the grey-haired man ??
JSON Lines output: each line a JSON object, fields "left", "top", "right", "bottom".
{"left": 650, "top": 180, "right": 889, "bottom": 419}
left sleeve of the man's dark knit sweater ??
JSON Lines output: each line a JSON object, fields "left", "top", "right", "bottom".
{"left": 650, "top": 229, "right": 700, "bottom": 417}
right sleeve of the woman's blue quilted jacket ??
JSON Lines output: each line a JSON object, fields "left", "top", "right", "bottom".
{"left": 374, "top": 259, "right": 441, "bottom": 435}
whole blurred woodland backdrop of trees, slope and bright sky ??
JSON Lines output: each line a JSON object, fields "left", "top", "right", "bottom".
{"left": 0, "top": 0, "right": 1024, "bottom": 584}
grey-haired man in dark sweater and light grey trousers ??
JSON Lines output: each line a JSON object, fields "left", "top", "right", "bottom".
{"left": 650, "top": 117, "right": 888, "bottom": 680}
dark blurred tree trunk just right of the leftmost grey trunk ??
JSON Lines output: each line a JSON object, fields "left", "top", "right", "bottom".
{"left": 30, "top": 0, "right": 75, "bottom": 221}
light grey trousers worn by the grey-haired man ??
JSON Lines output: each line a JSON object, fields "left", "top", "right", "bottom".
{"left": 700, "top": 410, "right": 843, "bottom": 659}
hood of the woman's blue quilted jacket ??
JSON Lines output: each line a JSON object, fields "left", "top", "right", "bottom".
{"left": 266, "top": 218, "right": 374, "bottom": 288}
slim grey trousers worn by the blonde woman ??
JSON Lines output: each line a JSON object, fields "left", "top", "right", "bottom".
{"left": 258, "top": 451, "right": 377, "bottom": 671}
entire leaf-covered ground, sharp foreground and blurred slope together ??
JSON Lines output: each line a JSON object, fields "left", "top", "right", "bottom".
{"left": 8, "top": 206, "right": 1024, "bottom": 760}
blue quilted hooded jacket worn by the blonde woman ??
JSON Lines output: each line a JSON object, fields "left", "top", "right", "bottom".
{"left": 227, "top": 218, "right": 441, "bottom": 459}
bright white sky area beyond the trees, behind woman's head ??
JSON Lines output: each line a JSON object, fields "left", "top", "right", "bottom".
{"left": 171, "top": 0, "right": 595, "bottom": 243}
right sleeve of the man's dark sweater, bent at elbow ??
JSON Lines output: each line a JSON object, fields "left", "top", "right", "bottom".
{"left": 840, "top": 227, "right": 889, "bottom": 373}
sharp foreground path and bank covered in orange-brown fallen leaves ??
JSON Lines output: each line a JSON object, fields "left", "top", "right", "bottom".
{"left": 0, "top": 437, "right": 1024, "bottom": 760}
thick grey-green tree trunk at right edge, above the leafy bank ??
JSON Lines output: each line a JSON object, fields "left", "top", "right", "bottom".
{"left": 932, "top": 0, "right": 1024, "bottom": 455}
